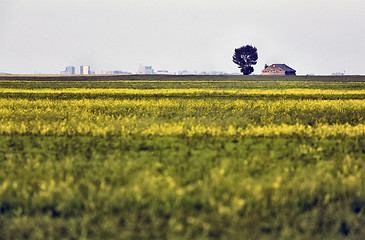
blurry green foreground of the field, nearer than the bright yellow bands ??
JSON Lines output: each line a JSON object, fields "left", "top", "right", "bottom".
{"left": 0, "top": 136, "right": 365, "bottom": 239}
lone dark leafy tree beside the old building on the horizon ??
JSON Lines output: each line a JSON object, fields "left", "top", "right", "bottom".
{"left": 233, "top": 45, "right": 258, "bottom": 75}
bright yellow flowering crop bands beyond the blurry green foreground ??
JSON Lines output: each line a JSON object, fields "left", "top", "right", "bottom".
{"left": 0, "top": 88, "right": 365, "bottom": 138}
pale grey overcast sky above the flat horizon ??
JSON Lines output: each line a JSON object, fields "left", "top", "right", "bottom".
{"left": 0, "top": 0, "right": 365, "bottom": 74}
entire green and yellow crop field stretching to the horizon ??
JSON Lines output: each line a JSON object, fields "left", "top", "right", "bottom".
{"left": 0, "top": 77, "right": 365, "bottom": 240}
